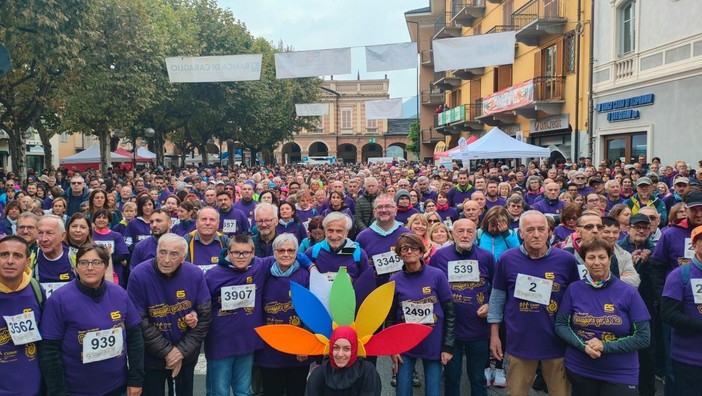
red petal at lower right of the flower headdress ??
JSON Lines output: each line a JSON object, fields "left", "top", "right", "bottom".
{"left": 365, "top": 323, "right": 432, "bottom": 356}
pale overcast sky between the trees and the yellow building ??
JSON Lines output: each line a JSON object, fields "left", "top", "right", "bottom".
{"left": 218, "top": 0, "right": 430, "bottom": 98}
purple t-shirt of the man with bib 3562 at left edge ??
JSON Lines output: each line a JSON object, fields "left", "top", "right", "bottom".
{"left": 0, "top": 285, "right": 42, "bottom": 396}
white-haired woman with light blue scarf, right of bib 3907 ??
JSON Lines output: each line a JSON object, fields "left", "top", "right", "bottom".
{"left": 255, "top": 234, "right": 310, "bottom": 396}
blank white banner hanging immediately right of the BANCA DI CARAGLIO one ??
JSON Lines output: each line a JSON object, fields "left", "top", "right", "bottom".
{"left": 275, "top": 48, "right": 351, "bottom": 79}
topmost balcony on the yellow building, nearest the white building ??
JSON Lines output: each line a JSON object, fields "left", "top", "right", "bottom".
{"left": 512, "top": 0, "right": 567, "bottom": 46}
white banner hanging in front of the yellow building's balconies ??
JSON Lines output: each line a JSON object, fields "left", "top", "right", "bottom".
{"left": 432, "top": 32, "right": 517, "bottom": 72}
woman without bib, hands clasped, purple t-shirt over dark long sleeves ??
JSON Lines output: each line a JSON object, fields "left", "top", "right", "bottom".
{"left": 555, "top": 236, "right": 651, "bottom": 396}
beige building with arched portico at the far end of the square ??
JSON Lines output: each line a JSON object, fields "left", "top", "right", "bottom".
{"left": 274, "top": 78, "right": 407, "bottom": 164}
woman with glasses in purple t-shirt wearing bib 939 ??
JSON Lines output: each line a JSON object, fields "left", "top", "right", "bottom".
{"left": 39, "top": 245, "right": 144, "bottom": 395}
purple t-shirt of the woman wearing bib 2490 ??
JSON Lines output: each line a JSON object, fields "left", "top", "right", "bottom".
{"left": 390, "top": 265, "right": 451, "bottom": 360}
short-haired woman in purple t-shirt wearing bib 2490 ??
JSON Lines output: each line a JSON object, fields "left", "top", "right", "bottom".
{"left": 388, "top": 233, "right": 456, "bottom": 396}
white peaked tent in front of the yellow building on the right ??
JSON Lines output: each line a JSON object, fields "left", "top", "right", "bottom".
{"left": 451, "top": 128, "right": 550, "bottom": 160}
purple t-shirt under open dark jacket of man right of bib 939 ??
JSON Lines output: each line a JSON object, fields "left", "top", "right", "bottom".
{"left": 127, "top": 260, "right": 210, "bottom": 368}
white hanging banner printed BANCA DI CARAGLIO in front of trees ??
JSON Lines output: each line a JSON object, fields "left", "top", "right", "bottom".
{"left": 166, "top": 54, "right": 263, "bottom": 83}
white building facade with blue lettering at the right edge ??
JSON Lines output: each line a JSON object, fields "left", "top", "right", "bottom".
{"left": 592, "top": 0, "right": 702, "bottom": 165}
